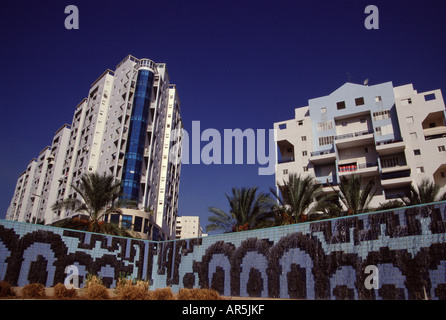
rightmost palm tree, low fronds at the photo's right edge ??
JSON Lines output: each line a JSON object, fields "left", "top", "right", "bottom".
{"left": 401, "top": 179, "right": 446, "bottom": 206}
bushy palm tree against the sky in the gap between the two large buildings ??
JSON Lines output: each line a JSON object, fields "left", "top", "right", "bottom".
{"left": 206, "top": 187, "right": 271, "bottom": 232}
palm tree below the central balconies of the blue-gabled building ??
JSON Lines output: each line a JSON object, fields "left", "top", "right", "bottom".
{"left": 339, "top": 175, "right": 377, "bottom": 215}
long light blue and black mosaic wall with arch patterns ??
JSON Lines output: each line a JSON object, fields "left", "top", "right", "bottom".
{"left": 0, "top": 202, "right": 446, "bottom": 299}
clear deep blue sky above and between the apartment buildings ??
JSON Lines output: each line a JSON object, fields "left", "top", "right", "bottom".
{"left": 0, "top": 0, "right": 446, "bottom": 232}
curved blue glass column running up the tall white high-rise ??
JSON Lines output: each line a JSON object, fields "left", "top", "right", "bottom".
{"left": 121, "top": 69, "right": 154, "bottom": 201}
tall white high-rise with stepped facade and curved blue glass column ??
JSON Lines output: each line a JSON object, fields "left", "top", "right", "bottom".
{"left": 6, "top": 55, "right": 182, "bottom": 239}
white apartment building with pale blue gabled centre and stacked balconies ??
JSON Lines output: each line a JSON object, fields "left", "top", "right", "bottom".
{"left": 274, "top": 82, "right": 446, "bottom": 206}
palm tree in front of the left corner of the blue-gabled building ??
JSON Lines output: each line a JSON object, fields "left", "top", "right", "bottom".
{"left": 270, "top": 173, "right": 325, "bottom": 225}
